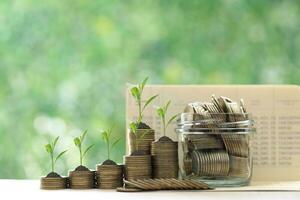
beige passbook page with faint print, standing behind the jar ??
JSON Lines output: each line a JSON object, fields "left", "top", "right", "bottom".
{"left": 126, "top": 85, "right": 300, "bottom": 181}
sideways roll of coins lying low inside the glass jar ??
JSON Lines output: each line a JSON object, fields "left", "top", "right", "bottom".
{"left": 191, "top": 150, "right": 229, "bottom": 176}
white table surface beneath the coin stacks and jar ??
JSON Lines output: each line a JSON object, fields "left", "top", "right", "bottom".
{"left": 0, "top": 179, "right": 300, "bottom": 200}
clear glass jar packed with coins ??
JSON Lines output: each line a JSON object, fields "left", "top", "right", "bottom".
{"left": 176, "top": 113, "right": 256, "bottom": 187}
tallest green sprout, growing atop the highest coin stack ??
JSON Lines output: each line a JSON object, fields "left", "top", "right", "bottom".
{"left": 130, "top": 77, "right": 158, "bottom": 126}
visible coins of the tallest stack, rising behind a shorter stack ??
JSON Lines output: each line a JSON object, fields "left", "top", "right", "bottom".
{"left": 129, "top": 129, "right": 155, "bottom": 155}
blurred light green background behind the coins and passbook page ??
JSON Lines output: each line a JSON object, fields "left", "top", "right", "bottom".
{"left": 0, "top": 0, "right": 300, "bottom": 178}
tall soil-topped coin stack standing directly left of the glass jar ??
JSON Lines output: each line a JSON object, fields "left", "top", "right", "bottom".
{"left": 151, "top": 137, "right": 178, "bottom": 178}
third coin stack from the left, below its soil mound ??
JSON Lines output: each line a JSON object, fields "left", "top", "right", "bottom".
{"left": 97, "top": 165, "right": 123, "bottom": 189}
